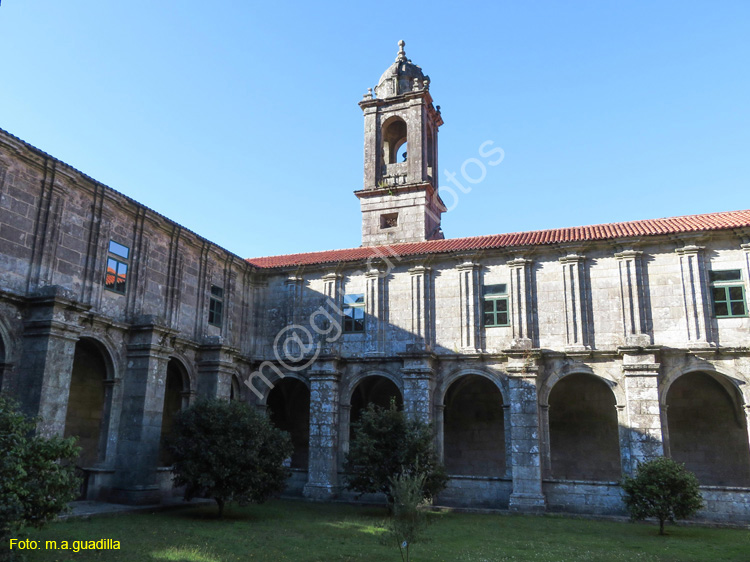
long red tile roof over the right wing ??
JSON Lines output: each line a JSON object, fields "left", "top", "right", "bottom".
{"left": 247, "top": 210, "right": 750, "bottom": 268}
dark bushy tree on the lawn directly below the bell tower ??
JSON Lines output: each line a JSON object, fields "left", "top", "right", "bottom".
{"left": 345, "top": 403, "right": 448, "bottom": 503}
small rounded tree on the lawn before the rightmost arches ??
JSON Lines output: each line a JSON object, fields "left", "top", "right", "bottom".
{"left": 622, "top": 457, "right": 703, "bottom": 535}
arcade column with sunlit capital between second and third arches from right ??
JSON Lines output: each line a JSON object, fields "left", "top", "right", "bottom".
{"left": 507, "top": 353, "right": 546, "bottom": 511}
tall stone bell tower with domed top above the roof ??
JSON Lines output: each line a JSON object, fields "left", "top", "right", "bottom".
{"left": 355, "top": 41, "right": 446, "bottom": 246}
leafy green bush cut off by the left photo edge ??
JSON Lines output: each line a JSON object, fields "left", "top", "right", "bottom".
{"left": 0, "top": 396, "right": 81, "bottom": 544}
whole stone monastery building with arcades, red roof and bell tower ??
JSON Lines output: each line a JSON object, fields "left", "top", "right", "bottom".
{"left": 0, "top": 43, "right": 750, "bottom": 521}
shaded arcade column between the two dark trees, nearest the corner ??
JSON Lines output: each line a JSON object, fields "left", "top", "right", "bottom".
{"left": 303, "top": 357, "right": 341, "bottom": 499}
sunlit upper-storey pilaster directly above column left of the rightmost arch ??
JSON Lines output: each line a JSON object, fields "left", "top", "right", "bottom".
{"left": 615, "top": 250, "right": 651, "bottom": 346}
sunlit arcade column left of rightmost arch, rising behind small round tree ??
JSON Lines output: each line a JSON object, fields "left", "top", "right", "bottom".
{"left": 619, "top": 348, "right": 664, "bottom": 474}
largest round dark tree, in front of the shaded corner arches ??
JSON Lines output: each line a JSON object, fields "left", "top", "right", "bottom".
{"left": 167, "top": 400, "right": 292, "bottom": 518}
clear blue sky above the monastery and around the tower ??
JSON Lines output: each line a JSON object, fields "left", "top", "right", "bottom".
{"left": 0, "top": 0, "right": 750, "bottom": 257}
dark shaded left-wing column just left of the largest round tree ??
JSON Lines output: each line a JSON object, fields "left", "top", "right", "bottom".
{"left": 111, "top": 318, "right": 174, "bottom": 504}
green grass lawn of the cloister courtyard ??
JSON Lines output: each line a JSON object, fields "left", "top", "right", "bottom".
{"left": 14, "top": 500, "right": 750, "bottom": 562}
